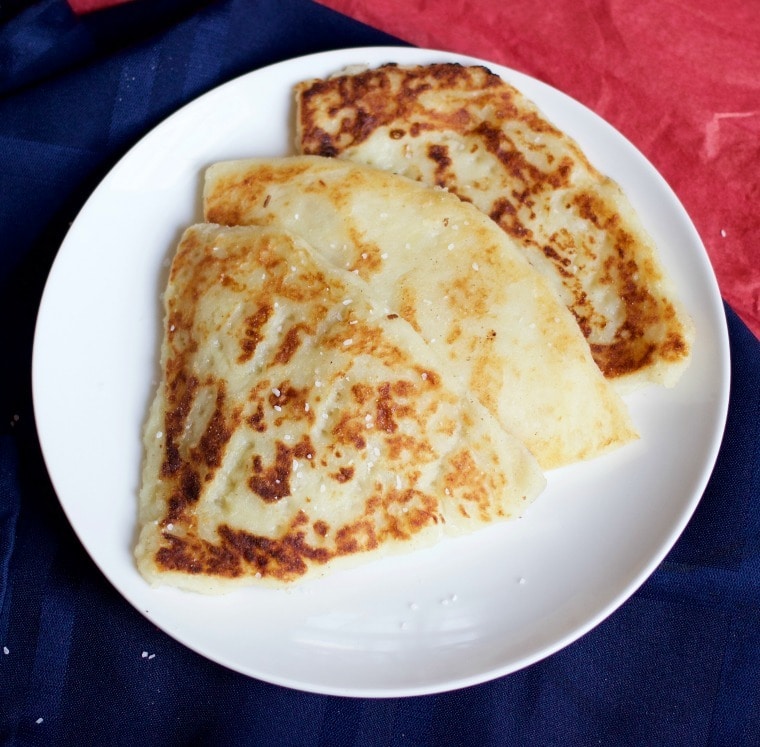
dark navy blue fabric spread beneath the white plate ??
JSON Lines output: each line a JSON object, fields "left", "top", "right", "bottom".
{"left": 0, "top": 0, "right": 760, "bottom": 747}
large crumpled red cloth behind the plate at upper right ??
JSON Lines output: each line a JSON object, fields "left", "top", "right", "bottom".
{"left": 319, "top": 0, "right": 760, "bottom": 337}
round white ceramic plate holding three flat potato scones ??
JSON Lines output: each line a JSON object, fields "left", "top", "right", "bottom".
{"left": 33, "top": 48, "right": 729, "bottom": 696}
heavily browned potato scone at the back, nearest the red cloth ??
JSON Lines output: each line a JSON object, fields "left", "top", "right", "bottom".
{"left": 296, "top": 63, "right": 693, "bottom": 391}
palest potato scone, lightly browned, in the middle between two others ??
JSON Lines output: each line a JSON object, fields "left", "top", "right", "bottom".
{"left": 204, "top": 156, "right": 636, "bottom": 469}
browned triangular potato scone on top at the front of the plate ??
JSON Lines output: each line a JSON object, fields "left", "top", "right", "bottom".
{"left": 135, "top": 224, "right": 545, "bottom": 592}
